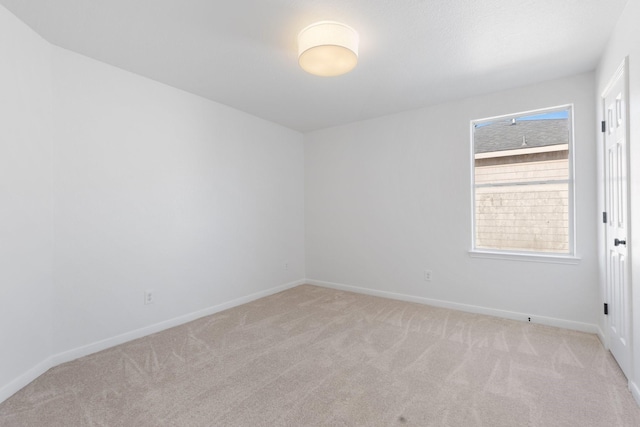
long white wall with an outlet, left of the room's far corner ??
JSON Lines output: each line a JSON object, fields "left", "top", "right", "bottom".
{"left": 53, "top": 48, "right": 305, "bottom": 358}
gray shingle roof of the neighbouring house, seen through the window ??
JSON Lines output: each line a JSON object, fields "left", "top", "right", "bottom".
{"left": 474, "top": 119, "right": 569, "bottom": 154}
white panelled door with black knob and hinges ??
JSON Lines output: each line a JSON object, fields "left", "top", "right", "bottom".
{"left": 602, "top": 60, "right": 631, "bottom": 378}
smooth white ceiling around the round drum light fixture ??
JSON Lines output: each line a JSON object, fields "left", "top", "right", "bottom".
{"left": 0, "top": 0, "right": 627, "bottom": 131}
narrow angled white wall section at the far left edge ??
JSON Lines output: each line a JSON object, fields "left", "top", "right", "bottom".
{"left": 0, "top": 7, "right": 52, "bottom": 401}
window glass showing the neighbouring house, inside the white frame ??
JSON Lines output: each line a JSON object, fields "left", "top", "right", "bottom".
{"left": 471, "top": 106, "right": 574, "bottom": 257}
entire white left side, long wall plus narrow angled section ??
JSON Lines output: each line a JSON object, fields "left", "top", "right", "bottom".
{"left": 0, "top": 6, "right": 305, "bottom": 401}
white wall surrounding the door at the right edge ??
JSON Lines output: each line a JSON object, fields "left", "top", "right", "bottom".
{"left": 597, "top": 1, "right": 640, "bottom": 402}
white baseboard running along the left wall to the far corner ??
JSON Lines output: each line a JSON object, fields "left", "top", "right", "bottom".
{"left": 0, "top": 280, "right": 306, "bottom": 403}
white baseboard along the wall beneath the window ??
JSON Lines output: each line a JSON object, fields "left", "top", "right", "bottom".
{"left": 306, "top": 279, "right": 604, "bottom": 336}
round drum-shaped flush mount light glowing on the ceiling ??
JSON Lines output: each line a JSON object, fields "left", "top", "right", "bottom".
{"left": 298, "top": 21, "right": 358, "bottom": 77}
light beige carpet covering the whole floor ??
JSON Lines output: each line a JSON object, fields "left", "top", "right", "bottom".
{"left": 0, "top": 285, "right": 640, "bottom": 427}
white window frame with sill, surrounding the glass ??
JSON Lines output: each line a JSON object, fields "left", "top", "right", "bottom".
{"left": 469, "top": 104, "right": 580, "bottom": 264}
